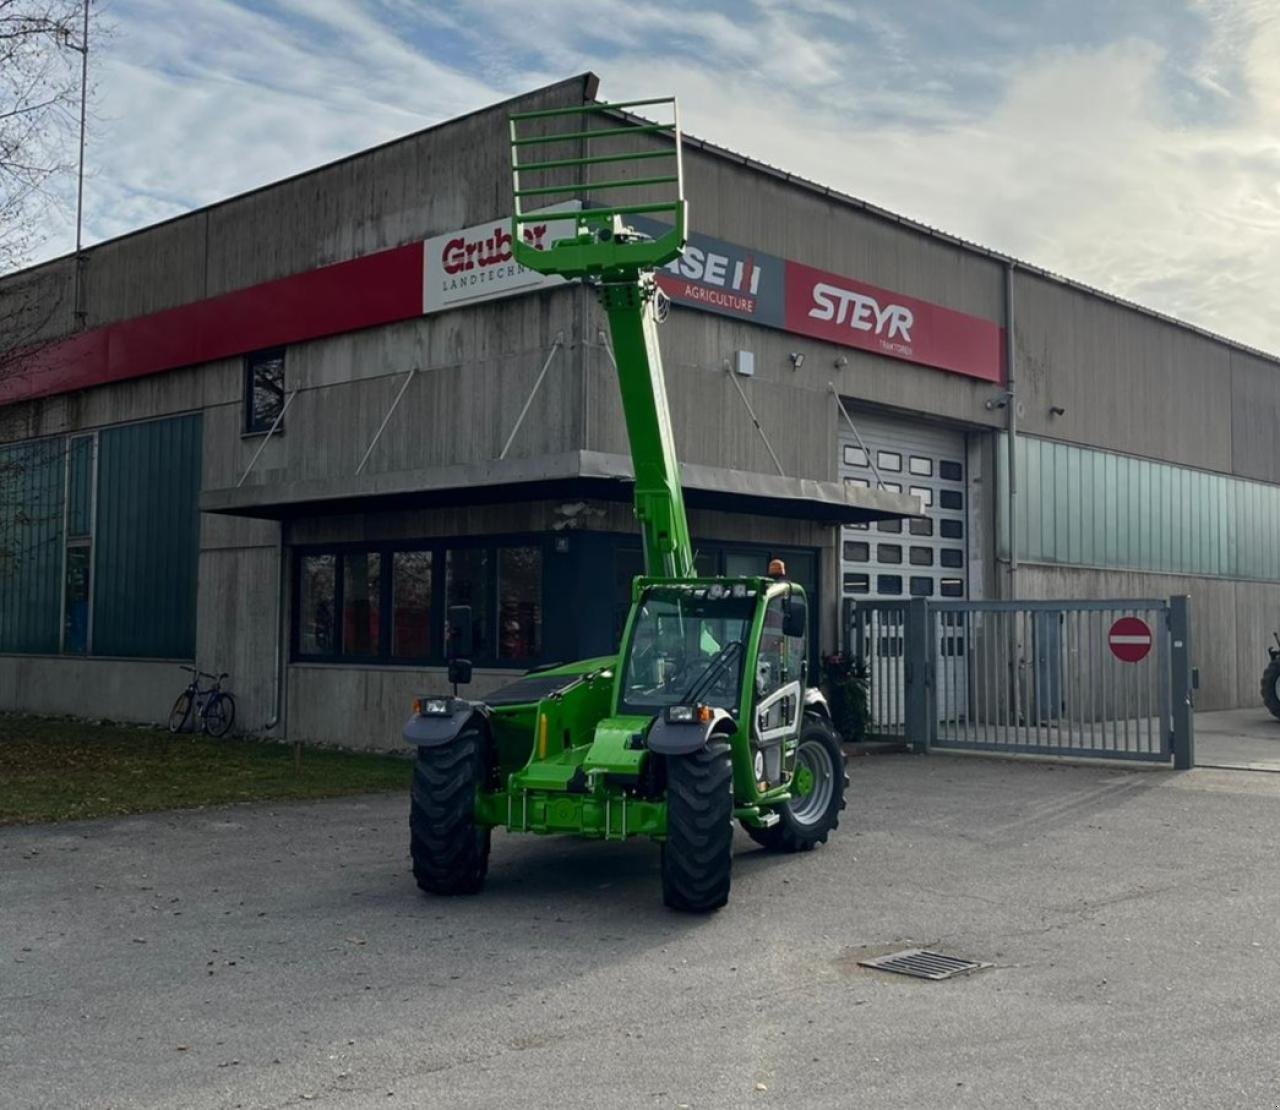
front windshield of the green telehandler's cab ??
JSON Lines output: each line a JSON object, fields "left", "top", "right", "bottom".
{"left": 618, "top": 584, "right": 755, "bottom": 713}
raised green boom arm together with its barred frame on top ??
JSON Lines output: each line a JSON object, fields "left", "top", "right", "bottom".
{"left": 511, "top": 99, "right": 695, "bottom": 579}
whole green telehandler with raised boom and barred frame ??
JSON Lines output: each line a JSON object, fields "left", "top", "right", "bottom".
{"left": 404, "top": 100, "right": 849, "bottom": 912}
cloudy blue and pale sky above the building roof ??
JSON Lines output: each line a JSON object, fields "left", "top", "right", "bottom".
{"left": 22, "top": 0, "right": 1280, "bottom": 353}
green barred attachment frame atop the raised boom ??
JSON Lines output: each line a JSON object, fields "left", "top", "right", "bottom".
{"left": 511, "top": 96, "right": 687, "bottom": 282}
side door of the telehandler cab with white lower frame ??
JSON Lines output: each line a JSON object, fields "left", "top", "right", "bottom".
{"left": 748, "top": 590, "right": 805, "bottom": 789}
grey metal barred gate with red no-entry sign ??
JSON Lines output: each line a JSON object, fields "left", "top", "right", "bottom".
{"left": 847, "top": 597, "right": 1193, "bottom": 767}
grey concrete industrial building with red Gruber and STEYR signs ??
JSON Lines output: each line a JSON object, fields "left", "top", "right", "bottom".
{"left": 0, "top": 74, "right": 1280, "bottom": 746}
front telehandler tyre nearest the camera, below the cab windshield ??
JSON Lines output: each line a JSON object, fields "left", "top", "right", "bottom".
{"left": 662, "top": 737, "right": 733, "bottom": 913}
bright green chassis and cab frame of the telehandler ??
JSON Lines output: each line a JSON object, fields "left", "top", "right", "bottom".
{"left": 465, "top": 577, "right": 813, "bottom": 841}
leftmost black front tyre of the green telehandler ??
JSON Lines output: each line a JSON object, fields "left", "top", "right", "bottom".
{"left": 408, "top": 725, "right": 490, "bottom": 894}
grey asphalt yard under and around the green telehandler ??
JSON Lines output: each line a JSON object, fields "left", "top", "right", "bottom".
{"left": 0, "top": 755, "right": 1280, "bottom": 1110}
